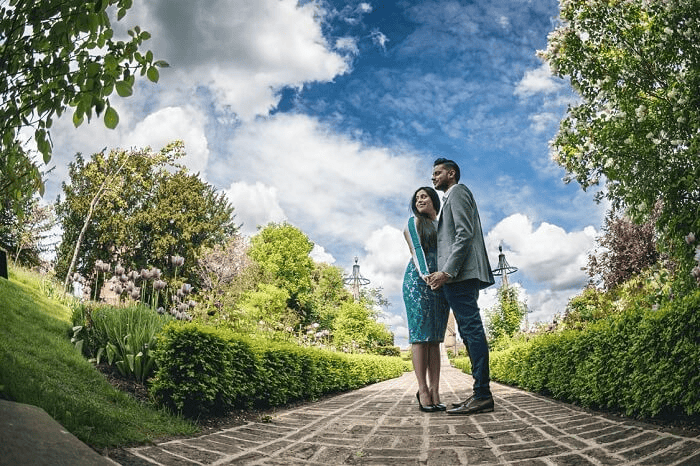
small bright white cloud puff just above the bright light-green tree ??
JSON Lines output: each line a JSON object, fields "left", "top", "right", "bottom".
{"left": 225, "top": 182, "right": 287, "bottom": 236}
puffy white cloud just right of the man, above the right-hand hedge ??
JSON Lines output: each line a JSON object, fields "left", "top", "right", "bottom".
{"left": 486, "top": 214, "right": 596, "bottom": 291}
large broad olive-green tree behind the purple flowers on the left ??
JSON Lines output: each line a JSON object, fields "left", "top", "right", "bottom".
{"left": 56, "top": 142, "right": 236, "bottom": 294}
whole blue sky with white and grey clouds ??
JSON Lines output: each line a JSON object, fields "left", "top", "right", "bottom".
{"left": 46, "top": 0, "right": 605, "bottom": 345}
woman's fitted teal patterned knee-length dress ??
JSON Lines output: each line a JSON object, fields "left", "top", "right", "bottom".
{"left": 403, "top": 218, "right": 450, "bottom": 343}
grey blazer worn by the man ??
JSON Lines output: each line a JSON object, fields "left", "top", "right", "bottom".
{"left": 437, "top": 184, "right": 495, "bottom": 289}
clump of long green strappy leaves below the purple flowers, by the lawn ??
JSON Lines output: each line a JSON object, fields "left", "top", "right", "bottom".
{"left": 71, "top": 303, "right": 172, "bottom": 383}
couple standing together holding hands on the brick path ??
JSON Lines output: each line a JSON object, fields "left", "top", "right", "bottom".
{"left": 403, "top": 158, "right": 494, "bottom": 414}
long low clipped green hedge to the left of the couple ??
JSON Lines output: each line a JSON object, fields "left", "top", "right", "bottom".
{"left": 150, "top": 323, "right": 410, "bottom": 417}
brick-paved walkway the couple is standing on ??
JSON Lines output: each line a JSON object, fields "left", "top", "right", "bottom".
{"left": 119, "top": 367, "right": 700, "bottom": 466}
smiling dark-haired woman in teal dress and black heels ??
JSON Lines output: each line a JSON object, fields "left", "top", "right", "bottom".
{"left": 403, "top": 187, "right": 449, "bottom": 412}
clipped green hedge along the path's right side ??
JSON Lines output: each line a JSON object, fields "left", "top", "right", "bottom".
{"left": 486, "top": 292, "right": 700, "bottom": 416}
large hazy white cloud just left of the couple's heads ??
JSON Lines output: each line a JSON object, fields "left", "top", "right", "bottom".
{"left": 221, "top": 114, "right": 428, "bottom": 246}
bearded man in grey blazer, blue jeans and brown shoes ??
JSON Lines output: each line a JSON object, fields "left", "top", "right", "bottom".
{"left": 427, "top": 158, "right": 494, "bottom": 414}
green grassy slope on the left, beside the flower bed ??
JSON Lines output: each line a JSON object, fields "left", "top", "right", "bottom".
{"left": 0, "top": 270, "right": 196, "bottom": 449}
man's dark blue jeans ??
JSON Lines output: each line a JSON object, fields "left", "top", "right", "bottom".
{"left": 442, "top": 280, "right": 491, "bottom": 398}
